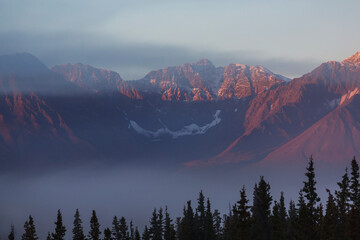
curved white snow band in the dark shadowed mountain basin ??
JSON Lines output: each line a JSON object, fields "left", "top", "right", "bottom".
{"left": 129, "top": 110, "right": 221, "bottom": 139}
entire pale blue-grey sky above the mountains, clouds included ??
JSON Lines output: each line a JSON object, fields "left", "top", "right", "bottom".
{"left": 0, "top": 0, "right": 360, "bottom": 80}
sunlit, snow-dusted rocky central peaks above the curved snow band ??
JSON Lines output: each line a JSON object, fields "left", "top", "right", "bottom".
{"left": 135, "top": 59, "right": 289, "bottom": 101}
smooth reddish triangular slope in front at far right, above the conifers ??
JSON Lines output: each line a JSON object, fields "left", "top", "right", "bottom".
{"left": 262, "top": 91, "right": 360, "bottom": 166}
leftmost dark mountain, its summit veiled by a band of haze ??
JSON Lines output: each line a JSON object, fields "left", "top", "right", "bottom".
{"left": 0, "top": 53, "right": 98, "bottom": 168}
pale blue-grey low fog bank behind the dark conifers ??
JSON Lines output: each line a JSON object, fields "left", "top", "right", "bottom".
{"left": 0, "top": 160, "right": 343, "bottom": 239}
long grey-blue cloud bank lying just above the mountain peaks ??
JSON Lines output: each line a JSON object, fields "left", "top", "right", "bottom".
{"left": 0, "top": 31, "right": 320, "bottom": 80}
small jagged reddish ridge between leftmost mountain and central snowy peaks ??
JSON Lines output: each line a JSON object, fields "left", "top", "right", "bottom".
{"left": 52, "top": 63, "right": 141, "bottom": 99}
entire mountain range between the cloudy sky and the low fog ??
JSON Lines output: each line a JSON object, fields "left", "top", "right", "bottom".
{"left": 0, "top": 52, "right": 360, "bottom": 170}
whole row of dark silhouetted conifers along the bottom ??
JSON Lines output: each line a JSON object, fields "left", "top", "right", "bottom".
{"left": 4, "top": 157, "right": 360, "bottom": 240}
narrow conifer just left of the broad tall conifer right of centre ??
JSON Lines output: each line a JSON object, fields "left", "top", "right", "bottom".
{"left": 236, "top": 186, "right": 251, "bottom": 240}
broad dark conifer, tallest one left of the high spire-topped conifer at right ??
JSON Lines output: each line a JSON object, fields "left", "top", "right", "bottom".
{"left": 251, "top": 176, "right": 272, "bottom": 239}
